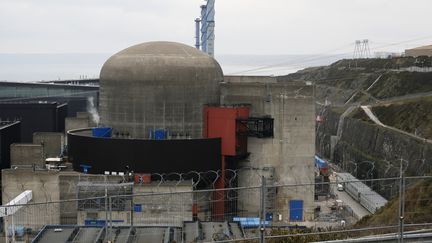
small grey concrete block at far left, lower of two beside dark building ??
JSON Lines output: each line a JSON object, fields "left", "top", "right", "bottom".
{"left": 11, "top": 143, "right": 45, "bottom": 168}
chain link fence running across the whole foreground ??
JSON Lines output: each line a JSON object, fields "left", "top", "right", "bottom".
{"left": 1, "top": 176, "right": 432, "bottom": 242}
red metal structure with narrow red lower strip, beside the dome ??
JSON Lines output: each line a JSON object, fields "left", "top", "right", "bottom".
{"left": 203, "top": 105, "right": 250, "bottom": 220}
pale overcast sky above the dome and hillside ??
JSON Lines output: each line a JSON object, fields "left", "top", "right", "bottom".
{"left": 0, "top": 0, "right": 432, "bottom": 55}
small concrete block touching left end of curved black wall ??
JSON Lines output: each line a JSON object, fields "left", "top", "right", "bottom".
{"left": 33, "top": 132, "right": 64, "bottom": 158}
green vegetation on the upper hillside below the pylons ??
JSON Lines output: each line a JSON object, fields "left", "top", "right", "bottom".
{"left": 278, "top": 57, "right": 432, "bottom": 103}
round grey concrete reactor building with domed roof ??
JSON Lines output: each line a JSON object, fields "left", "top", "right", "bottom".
{"left": 100, "top": 42, "right": 223, "bottom": 138}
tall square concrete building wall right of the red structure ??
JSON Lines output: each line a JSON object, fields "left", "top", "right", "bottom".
{"left": 221, "top": 82, "right": 315, "bottom": 221}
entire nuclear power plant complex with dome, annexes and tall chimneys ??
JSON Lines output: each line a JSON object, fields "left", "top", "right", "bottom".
{"left": 0, "top": 0, "right": 316, "bottom": 239}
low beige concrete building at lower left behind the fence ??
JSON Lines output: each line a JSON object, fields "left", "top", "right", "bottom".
{"left": 2, "top": 168, "right": 130, "bottom": 230}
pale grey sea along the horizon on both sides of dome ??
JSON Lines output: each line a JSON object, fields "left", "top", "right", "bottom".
{"left": 0, "top": 53, "right": 348, "bottom": 82}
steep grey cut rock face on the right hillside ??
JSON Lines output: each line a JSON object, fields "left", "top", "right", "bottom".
{"left": 316, "top": 109, "right": 432, "bottom": 196}
